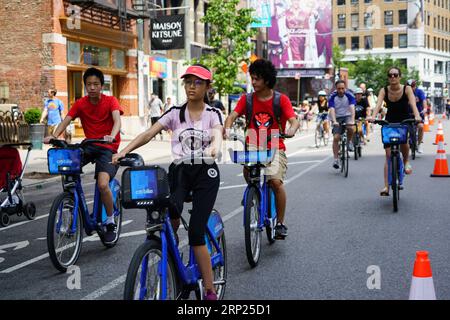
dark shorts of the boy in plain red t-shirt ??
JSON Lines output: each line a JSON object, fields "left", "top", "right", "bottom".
{"left": 83, "top": 145, "right": 119, "bottom": 180}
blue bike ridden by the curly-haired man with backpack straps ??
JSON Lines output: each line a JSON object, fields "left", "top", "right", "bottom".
{"left": 229, "top": 134, "right": 287, "bottom": 268}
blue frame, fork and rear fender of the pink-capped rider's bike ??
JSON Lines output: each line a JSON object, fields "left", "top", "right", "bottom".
{"left": 139, "top": 210, "right": 225, "bottom": 300}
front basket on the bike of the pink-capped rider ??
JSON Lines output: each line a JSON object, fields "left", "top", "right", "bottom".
{"left": 122, "top": 166, "right": 170, "bottom": 209}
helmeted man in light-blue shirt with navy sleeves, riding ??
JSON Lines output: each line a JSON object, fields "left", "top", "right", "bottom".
{"left": 328, "top": 80, "right": 356, "bottom": 169}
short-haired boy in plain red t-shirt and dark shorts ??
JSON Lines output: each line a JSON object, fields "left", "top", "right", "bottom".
{"left": 44, "top": 68, "right": 123, "bottom": 243}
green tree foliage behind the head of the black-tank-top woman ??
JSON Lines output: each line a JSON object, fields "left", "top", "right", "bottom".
{"left": 350, "top": 55, "right": 420, "bottom": 95}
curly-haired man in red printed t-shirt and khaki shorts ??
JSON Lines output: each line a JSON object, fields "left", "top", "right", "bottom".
{"left": 225, "top": 59, "right": 299, "bottom": 239}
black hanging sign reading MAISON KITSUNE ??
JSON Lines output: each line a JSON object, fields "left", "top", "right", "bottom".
{"left": 150, "top": 14, "right": 185, "bottom": 50}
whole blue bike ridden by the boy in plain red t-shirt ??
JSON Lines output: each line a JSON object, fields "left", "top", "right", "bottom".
{"left": 47, "top": 139, "right": 122, "bottom": 272}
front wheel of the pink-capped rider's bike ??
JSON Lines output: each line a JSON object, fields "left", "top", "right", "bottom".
{"left": 124, "top": 239, "right": 179, "bottom": 300}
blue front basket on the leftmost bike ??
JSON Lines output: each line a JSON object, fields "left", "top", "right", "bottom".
{"left": 47, "top": 148, "right": 83, "bottom": 174}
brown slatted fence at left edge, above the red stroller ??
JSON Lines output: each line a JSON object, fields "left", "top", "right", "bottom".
{"left": 0, "top": 111, "right": 30, "bottom": 143}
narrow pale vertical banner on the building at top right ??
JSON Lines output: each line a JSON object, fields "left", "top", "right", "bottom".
{"left": 408, "top": 0, "right": 425, "bottom": 47}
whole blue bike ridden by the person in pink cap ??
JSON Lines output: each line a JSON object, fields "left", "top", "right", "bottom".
{"left": 122, "top": 153, "right": 227, "bottom": 300}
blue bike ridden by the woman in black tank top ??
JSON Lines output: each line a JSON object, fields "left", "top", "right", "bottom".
{"left": 374, "top": 119, "right": 416, "bottom": 212}
